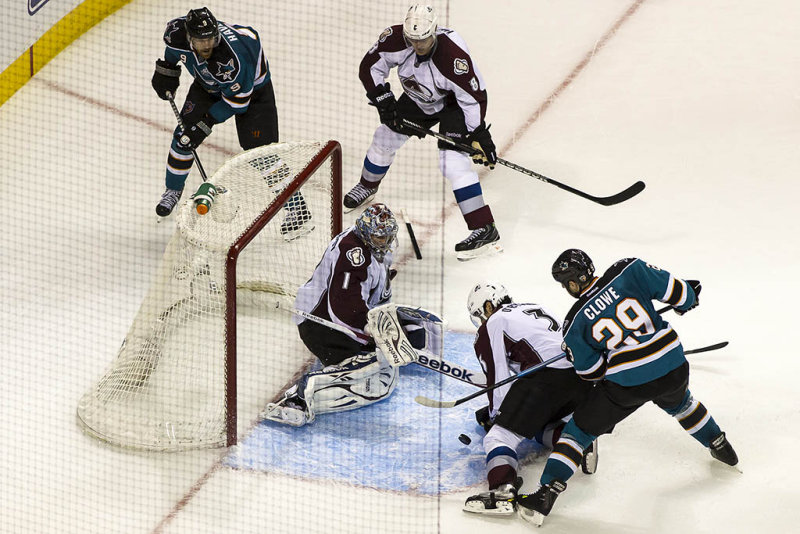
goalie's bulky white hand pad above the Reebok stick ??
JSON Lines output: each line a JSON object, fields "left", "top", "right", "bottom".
{"left": 367, "top": 304, "right": 444, "bottom": 367}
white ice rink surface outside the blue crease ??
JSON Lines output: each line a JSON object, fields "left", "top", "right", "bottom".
{"left": 0, "top": 0, "right": 800, "bottom": 534}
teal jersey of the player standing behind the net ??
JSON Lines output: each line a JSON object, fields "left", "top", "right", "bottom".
{"left": 164, "top": 17, "right": 270, "bottom": 122}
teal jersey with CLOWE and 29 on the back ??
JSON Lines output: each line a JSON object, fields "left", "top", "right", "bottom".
{"left": 564, "top": 258, "right": 696, "bottom": 386}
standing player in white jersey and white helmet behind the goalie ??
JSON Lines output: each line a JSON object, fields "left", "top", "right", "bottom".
{"left": 344, "top": 5, "right": 502, "bottom": 260}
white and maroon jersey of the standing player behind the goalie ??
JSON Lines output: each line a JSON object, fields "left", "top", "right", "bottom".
{"left": 358, "top": 24, "right": 486, "bottom": 132}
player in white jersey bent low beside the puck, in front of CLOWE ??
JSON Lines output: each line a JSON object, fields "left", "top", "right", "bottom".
{"left": 464, "top": 282, "right": 597, "bottom": 516}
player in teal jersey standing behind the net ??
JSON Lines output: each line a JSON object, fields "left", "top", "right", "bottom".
{"left": 152, "top": 7, "right": 311, "bottom": 234}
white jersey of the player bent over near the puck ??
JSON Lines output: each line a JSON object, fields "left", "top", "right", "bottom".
{"left": 475, "top": 304, "right": 572, "bottom": 416}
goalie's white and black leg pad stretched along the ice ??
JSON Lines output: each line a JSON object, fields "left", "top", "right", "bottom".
{"left": 303, "top": 352, "right": 398, "bottom": 418}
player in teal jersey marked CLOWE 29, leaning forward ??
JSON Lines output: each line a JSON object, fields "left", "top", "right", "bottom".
{"left": 517, "top": 249, "right": 738, "bottom": 525}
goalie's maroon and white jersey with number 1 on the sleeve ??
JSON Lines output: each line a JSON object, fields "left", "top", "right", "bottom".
{"left": 295, "top": 227, "right": 392, "bottom": 344}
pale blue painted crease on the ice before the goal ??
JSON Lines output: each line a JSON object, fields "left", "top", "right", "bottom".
{"left": 225, "top": 332, "right": 536, "bottom": 495}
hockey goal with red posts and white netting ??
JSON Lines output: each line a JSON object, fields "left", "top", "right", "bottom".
{"left": 77, "top": 141, "right": 341, "bottom": 450}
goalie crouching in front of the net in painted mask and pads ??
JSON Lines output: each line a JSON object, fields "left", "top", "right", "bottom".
{"left": 260, "top": 204, "right": 442, "bottom": 426}
